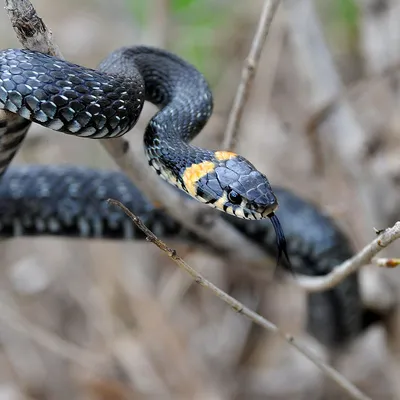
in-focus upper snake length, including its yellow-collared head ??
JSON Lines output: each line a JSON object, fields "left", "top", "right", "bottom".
{"left": 0, "top": 46, "right": 277, "bottom": 219}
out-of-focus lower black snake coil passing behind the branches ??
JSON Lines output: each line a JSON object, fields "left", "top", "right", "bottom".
{"left": 0, "top": 165, "right": 374, "bottom": 346}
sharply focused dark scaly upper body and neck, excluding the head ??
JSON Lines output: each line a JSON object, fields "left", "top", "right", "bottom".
{"left": 0, "top": 46, "right": 214, "bottom": 179}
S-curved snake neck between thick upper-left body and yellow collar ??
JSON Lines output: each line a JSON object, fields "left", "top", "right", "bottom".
{"left": 99, "top": 47, "right": 214, "bottom": 176}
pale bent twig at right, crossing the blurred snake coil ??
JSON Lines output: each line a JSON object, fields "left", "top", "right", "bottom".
{"left": 296, "top": 222, "right": 400, "bottom": 292}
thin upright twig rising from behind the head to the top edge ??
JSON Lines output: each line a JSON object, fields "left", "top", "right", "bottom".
{"left": 222, "top": 0, "right": 280, "bottom": 150}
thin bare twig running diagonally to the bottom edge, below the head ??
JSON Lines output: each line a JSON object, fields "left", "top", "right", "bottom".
{"left": 108, "top": 199, "right": 368, "bottom": 400}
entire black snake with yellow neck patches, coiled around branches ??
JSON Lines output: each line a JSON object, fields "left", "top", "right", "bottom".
{"left": 0, "top": 46, "right": 378, "bottom": 345}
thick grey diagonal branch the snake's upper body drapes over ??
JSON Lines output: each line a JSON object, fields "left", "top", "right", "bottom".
{"left": 5, "top": 0, "right": 272, "bottom": 265}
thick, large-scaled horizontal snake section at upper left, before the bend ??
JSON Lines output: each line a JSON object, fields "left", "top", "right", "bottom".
{"left": 0, "top": 49, "right": 144, "bottom": 138}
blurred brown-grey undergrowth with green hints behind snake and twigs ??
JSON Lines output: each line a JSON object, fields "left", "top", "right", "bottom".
{"left": 0, "top": 0, "right": 400, "bottom": 400}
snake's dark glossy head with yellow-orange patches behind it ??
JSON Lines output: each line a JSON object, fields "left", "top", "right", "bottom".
{"left": 183, "top": 151, "right": 278, "bottom": 220}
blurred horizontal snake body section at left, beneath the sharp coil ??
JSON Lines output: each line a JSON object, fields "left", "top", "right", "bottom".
{"left": 0, "top": 165, "right": 194, "bottom": 240}
